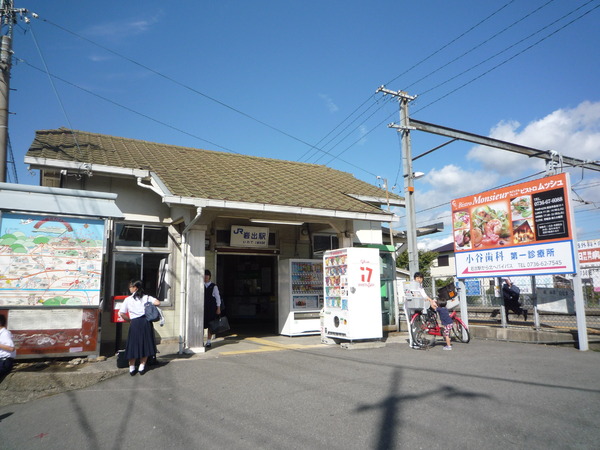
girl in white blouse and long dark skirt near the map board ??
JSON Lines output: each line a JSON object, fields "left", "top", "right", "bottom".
{"left": 119, "top": 280, "right": 160, "bottom": 376}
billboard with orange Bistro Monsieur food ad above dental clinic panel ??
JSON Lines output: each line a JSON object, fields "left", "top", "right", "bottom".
{"left": 452, "top": 174, "right": 576, "bottom": 278}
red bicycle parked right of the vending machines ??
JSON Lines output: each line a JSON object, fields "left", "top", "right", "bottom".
{"left": 410, "top": 310, "right": 471, "bottom": 348}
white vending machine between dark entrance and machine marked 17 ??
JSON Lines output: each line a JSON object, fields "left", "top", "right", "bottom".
{"left": 279, "top": 259, "right": 323, "bottom": 336}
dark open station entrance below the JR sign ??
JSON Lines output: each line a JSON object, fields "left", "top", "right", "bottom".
{"left": 215, "top": 254, "right": 277, "bottom": 335}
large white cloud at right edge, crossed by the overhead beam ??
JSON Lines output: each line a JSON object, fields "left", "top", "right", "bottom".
{"left": 467, "top": 101, "right": 600, "bottom": 174}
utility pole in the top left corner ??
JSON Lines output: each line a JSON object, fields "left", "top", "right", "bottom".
{"left": 0, "top": 0, "right": 27, "bottom": 182}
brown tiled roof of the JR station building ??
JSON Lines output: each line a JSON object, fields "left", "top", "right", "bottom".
{"left": 27, "top": 128, "right": 400, "bottom": 213}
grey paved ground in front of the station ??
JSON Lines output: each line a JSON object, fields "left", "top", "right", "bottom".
{"left": 0, "top": 337, "right": 600, "bottom": 449}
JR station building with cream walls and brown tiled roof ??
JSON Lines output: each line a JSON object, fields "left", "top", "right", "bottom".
{"left": 25, "top": 128, "right": 403, "bottom": 351}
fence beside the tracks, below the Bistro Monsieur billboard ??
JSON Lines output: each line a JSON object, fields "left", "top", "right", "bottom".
{"left": 423, "top": 265, "right": 600, "bottom": 335}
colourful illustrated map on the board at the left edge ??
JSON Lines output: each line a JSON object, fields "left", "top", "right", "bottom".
{"left": 0, "top": 214, "right": 104, "bottom": 307}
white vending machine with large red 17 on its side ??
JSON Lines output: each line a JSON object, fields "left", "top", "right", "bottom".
{"left": 323, "top": 247, "right": 383, "bottom": 340}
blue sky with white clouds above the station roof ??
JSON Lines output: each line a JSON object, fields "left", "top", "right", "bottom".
{"left": 7, "top": 0, "right": 600, "bottom": 249}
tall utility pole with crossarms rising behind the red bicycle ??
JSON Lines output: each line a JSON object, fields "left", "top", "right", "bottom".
{"left": 376, "top": 86, "right": 419, "bottom": 276}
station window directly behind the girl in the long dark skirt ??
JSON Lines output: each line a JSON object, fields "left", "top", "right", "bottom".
{"left": 113, "top": 223, "right": 170, "bottom": 302}
